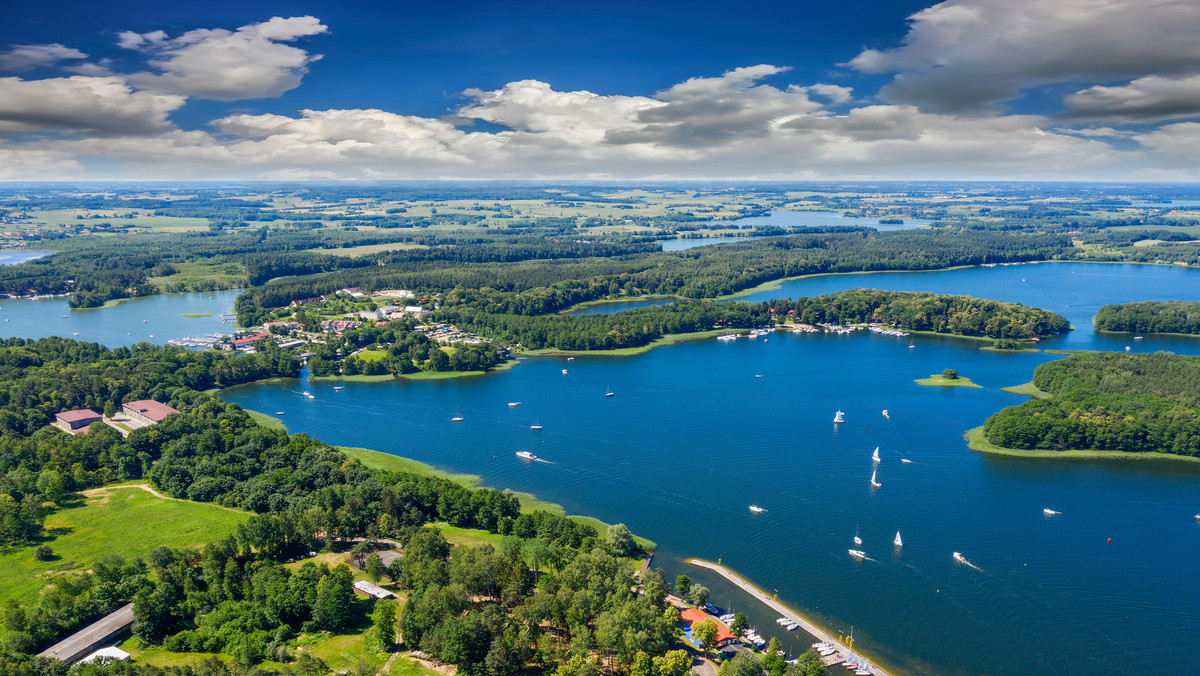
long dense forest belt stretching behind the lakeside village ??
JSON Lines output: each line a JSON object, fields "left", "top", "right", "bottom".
{"left": 235, "top": 231, "right": 1070, "bottom": 324}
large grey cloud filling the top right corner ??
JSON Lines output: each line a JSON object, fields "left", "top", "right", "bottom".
{"left": 848, "top": 0, "right": 1200, "bottom": 112}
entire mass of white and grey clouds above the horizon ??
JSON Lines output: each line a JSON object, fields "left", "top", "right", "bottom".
{"left": 7, "top": 0, "right": 1200, "bottom": 180}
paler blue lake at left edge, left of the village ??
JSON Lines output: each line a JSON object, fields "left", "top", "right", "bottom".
{"left": 0, "top": 289, "right": 240, "bottom": 347}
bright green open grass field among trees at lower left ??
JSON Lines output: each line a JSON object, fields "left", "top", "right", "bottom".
{"left": 0, "top": 486, "right": 250, "bottom": 604}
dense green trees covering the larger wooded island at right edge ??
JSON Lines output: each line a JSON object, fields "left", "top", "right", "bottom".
{"left": 984, "top": 352, "right": 1200, "bottom": 456}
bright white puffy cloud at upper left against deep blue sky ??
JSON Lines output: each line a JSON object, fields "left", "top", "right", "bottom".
{"left": 119, "top": 17, "right": 326, "bottom": 101}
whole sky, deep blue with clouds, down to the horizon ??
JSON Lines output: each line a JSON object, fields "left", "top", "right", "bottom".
{"left": 0, "top": 0, "right": 1200, "bottom": 180}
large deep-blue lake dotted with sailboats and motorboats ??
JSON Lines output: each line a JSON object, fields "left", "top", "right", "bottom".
{"left": 216, "top": 264, "right": 1200, "bottom": 675}
